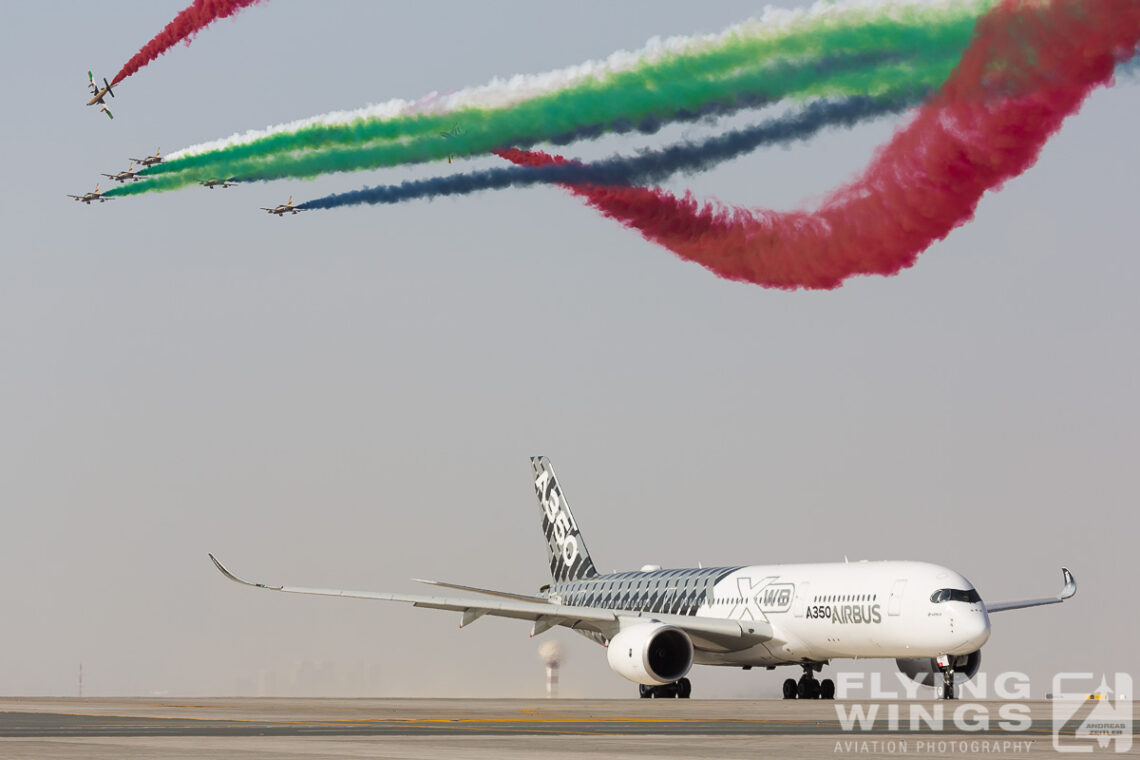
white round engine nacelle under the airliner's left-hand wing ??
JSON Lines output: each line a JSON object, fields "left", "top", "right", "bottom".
{"left": 605, "top": 623, "right": 693, "bottom": 686}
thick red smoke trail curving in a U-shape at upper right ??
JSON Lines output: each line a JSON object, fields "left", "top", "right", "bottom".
{"left": 499, "top": 0, "right": 1140, "bottom": 289}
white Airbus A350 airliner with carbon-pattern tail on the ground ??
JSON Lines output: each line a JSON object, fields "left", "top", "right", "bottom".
{"left": 209, "top": 457, "right": 1076, "bottom": 700}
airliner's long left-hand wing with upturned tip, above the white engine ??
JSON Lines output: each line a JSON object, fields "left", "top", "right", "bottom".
{"left": 210, "top": 554, "right": 774, "bottom": 652}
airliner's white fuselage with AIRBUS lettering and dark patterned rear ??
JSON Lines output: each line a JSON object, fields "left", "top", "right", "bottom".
{"left": 551, "top": 562, "right": 990, "bottom": 667}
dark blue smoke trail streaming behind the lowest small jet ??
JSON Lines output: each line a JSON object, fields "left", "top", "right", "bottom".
{"left": 298, "top": 90, "right": 927, "bottom": 209}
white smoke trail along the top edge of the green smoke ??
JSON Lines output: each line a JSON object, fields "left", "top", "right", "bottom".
{"left": 168, "top": 0, "right": 987, "bottom": 161}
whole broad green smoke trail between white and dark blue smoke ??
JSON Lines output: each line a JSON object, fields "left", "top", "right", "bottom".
{"left": 111, "top": 2, "right": 990, "bottom": 195}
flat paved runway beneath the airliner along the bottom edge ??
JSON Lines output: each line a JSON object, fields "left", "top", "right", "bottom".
{"left": 0, "top": 698, "right": 1135, "bottom": 760}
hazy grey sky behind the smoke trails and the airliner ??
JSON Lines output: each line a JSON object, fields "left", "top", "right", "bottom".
{"left": 0, "top": 0, "right": 1140, "bottom": 696}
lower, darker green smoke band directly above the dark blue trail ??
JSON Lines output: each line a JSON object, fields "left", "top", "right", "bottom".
{"left": 113, "top": 49, "right": 958, "bottom": 195}
